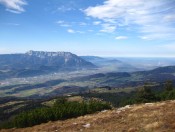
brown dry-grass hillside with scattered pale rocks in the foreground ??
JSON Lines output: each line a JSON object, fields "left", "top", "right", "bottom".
{"left": 1, "top": 100, "right": 175, "bottom": 132}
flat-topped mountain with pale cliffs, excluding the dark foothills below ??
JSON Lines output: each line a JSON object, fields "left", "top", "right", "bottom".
{"left": 0, "top": 51, "right": 95, "bottom": 69}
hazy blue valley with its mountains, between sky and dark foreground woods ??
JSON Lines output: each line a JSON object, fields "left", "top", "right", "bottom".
{"left": 0, "top": 51, "right": 175, "bottom": 97}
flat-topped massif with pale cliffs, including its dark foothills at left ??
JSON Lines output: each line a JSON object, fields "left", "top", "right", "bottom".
{"left": 0, "top": 51, "right": 96, "bottom": 78}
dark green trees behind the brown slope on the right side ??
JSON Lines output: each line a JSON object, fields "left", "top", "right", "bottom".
{"left": 81, "top": 80, "right": 175, "bottom": 107}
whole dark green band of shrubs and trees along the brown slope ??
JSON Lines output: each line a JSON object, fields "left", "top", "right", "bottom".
{"left": 0, "top": 81, "right": 175, "bottom": 128}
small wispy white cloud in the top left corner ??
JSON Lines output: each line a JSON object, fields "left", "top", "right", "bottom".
{"left": 0, "top": 0, "right": 27, "bottom": 13}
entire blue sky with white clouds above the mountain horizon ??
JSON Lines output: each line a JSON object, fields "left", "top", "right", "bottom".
{"left": 0, "top": 0, "right": 175, "bottom": 57}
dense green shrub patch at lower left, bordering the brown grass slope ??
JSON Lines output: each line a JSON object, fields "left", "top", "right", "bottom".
{"left": 1, "top": 98, "right": 111, "bottom": 128}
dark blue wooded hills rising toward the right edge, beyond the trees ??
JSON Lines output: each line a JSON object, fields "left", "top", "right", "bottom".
{"left": 72, "top": 66, "right": 175, "bottom": 88}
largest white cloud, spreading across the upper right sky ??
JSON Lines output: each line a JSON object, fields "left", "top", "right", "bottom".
{"left": 84, "top": 0, "right": 175, "bottom": 39}
